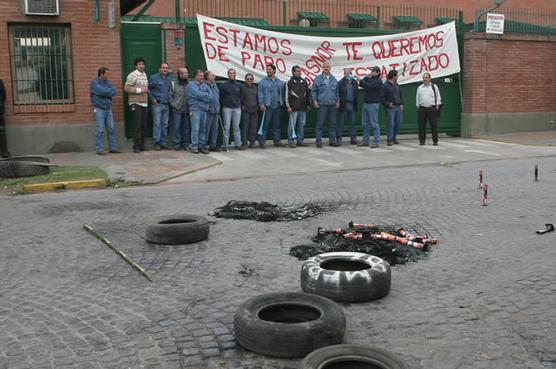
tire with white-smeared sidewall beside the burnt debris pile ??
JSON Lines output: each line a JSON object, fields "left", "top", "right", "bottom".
{"left": 301, "top": 252, "right": 392, "bottom": 302}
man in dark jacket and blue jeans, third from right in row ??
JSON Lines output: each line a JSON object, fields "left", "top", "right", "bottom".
{"left": 359, "top": 66, "right": 382, "bottom": 149}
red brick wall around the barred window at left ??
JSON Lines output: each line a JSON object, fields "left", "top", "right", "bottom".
{"left": 0, "top": 0, "right": 123, "bottom": 126}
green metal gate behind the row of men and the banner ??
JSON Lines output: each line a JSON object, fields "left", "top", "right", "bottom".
{"left": 121, "top": 12, "right": 463, "bottom": 137}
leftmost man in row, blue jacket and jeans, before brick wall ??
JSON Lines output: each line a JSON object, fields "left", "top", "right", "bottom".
{"left": 91, "top": 67, "right": 120, "bottom": 155}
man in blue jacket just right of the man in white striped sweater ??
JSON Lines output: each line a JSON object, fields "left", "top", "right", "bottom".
{"left": 149, "top": 62, "right": 173, "bottom": 150}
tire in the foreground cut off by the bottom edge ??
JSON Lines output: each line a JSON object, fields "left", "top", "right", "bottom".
{"left": 299, "top": 345, "right": 409, "bottom": 369}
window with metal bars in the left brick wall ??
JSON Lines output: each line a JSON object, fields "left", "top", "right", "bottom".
{"left": 8, "top": 23, "right": 74, "bottom": 105}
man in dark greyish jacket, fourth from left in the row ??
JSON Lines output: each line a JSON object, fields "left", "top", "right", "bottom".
{"left": 170, "top": 68, "right": 191, "bottom": 150}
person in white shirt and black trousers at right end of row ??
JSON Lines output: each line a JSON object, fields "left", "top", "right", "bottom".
{"left": 415, "top": 73, "right": 442, "bottom": 146}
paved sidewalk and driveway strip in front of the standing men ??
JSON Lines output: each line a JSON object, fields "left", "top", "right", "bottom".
{"left": 41, "top": 131, "right": 556, "bottom": 184}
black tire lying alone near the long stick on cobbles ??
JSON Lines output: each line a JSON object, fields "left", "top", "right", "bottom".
{"left": 145, "top": 215, "right": 209, "bottom": 245}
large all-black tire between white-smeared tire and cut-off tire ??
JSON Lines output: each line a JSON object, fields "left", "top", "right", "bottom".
{"left": 234, "top": 293, "right": 346, "bottom": 358}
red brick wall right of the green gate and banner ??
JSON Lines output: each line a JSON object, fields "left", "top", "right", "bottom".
{"left": 463, "top": 33, "right": 556, "bottom": 113}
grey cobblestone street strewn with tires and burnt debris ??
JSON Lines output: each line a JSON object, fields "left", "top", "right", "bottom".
{"left": 0, "top": 157, "right": 556, "bottom": 369}
